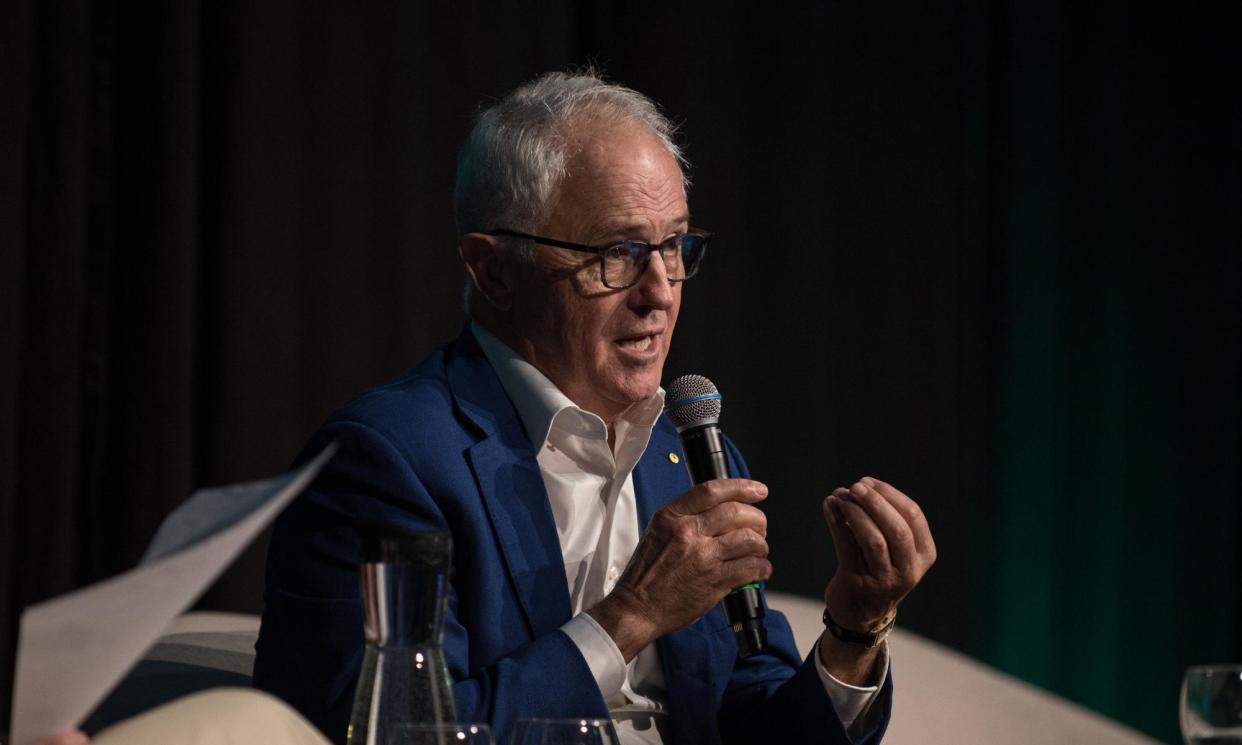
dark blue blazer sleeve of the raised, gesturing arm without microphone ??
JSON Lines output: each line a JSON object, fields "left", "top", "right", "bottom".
{"left": 719, "top": 440, "right": 893, "bottom": 745}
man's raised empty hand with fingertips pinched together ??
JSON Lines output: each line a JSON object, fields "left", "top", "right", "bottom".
{"left": 821, "top": 476, "right": 936, "bottom": 672}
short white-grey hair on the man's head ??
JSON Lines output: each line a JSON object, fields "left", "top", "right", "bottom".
{"left": 453, "top": 68, "right": 689, "bottom": 313}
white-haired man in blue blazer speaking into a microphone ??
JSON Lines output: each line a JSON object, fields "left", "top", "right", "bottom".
{"left": 255, "top": 72, "right": 935, "bottom": 745}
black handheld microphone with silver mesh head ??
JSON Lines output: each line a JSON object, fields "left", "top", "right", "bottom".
{"left": 664, "top": 375, "right": 768, "bottom": 658}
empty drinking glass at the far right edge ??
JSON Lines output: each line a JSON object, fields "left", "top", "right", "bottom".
{"left": 1179, "top": 664, "right": 1242, "bottom": 745}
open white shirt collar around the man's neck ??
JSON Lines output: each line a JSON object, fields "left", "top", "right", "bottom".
{"left": 469, "top": 320, "right": 664, "bottom": 449}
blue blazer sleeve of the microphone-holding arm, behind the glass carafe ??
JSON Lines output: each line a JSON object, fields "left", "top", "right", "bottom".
{"left": 253, "top": 421, "right": 607, "bottom": 743}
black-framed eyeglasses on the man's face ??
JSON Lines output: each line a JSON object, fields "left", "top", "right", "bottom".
{"left": 487, "top": 227, "right": 712, "bottom": 289}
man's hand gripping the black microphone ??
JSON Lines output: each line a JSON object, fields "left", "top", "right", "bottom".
{"left": 587, "top": 478, "right": 771, "bottom": 661}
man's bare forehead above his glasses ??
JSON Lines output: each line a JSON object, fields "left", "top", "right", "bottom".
{"left": 549, "top": 118, "right": 687, "bottom": 238}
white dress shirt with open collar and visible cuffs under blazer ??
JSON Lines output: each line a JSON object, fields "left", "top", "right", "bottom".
{"left": 471, "top": 323, "right": 888, "bottom": 745}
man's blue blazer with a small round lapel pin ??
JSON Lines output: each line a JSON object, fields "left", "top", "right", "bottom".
{"left": 253, "top": 329, "right": 892, "bottom": 745}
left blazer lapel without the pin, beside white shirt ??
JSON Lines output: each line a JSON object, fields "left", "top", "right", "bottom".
{"left": 446, "top": 329, "right": 570, "bottom": 638}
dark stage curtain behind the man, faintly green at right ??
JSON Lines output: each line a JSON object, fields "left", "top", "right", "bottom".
{"left": 0, "top": 0, "right": 1242, "bottom": 740}
